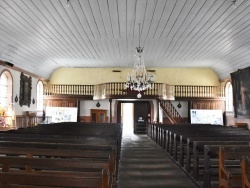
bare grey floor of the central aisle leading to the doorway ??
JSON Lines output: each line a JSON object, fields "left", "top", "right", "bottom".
{"left": 118, "top": 134, "right": 197, "bottom": 188}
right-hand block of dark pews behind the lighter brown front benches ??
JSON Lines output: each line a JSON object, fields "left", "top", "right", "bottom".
{"left": 147, "top": 124, "right": 250, "bottom": 188}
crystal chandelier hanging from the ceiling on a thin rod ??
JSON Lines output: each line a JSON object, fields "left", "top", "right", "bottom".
{"left": 125, "top": 24, "right": 153, "bottom": 98}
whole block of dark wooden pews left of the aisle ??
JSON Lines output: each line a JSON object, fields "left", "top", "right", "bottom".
{"left": 0, "top": 123, "right": 122, "bottom": 187}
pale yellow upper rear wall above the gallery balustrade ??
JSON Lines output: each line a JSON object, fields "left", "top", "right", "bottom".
{"left": 49, "top": 68, "right": 220, "bottom": 86}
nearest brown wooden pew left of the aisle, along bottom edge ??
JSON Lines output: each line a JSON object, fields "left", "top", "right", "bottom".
{"left": 0, "top": 169, "right": 111, "bottom": 188}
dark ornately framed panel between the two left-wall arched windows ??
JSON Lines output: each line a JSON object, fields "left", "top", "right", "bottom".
{"left": 19, "top": 73, "right": 32, "bottom": 107}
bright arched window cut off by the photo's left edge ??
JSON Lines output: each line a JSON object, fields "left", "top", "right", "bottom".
{"left": 0, "top": 71, "right": 13, "bottom": 109}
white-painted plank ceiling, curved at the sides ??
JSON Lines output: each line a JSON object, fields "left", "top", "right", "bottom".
{"left": 0, "top": 0, "right": 250, "bottom": 79}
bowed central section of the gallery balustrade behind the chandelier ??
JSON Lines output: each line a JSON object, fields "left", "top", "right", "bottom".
{"left": 93, "top": 82, "right": 174, "bottom": 100}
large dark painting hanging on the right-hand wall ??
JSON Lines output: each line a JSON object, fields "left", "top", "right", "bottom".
{"left": 231, "top": 67, "right": 250, "bottom": 118}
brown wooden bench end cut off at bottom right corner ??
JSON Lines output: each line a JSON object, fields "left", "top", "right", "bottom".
{"left": 241, "top": 156, "right": 250, "bottom": 188}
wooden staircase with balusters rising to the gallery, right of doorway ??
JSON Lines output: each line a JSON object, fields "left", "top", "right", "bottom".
{"left": 160, "top": 100, "right": 185, "bottom": 124}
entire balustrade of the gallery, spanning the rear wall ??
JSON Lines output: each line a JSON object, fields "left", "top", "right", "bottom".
{"left": 44, "top": 82, "right": 225, "bottom": 100}
